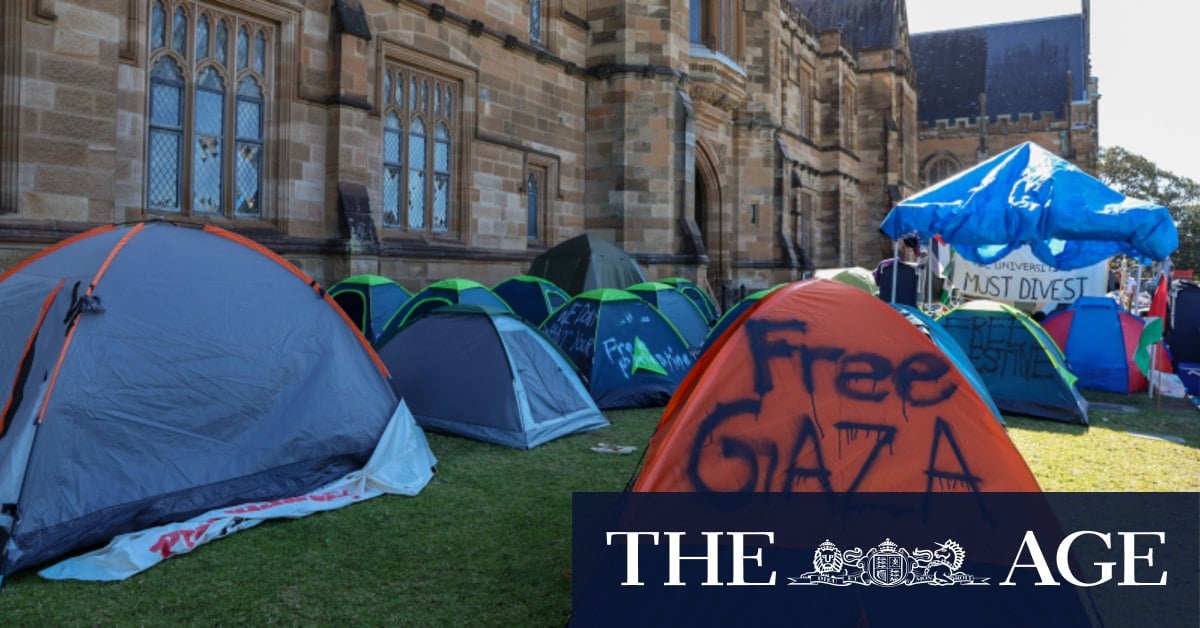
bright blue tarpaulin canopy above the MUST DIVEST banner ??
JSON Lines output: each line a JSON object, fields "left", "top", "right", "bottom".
{"left": 881, "top": 142, "right": 1180, "bottom": 270}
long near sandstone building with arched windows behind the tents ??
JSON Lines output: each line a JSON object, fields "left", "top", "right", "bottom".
{"left": 0, "top": 0, "right": 916, "bottom": 300}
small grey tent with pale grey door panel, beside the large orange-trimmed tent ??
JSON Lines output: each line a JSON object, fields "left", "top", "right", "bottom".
{"left": 379, "top": 305, "right": 608, "bottom": 449}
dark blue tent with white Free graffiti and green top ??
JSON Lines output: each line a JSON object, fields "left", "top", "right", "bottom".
{"left": 541, "top": 288, "right": 694, "bottom": 409}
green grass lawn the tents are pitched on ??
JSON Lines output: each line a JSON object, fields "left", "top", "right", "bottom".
{"left": 0, "top": 394, "right": 1200, "bottom": 626}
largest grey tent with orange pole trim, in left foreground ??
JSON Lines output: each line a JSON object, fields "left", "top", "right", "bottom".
{"left": 0, "top": 222, "right": 432, "bottom": 575}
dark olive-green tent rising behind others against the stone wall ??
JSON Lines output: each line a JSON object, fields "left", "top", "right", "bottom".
{"left": 528, "top": 233, "right": 646, "bottom": 297}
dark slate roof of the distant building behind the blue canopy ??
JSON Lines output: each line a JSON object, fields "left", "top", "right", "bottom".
{"left": 911, "top": 14, "right": 1087, "bottom": 122}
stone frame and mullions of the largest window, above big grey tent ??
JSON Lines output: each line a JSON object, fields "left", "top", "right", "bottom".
{"left": 139, "top": 0, "right": 301, "bottom": 227}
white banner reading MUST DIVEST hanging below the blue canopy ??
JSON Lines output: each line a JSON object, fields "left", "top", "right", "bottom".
{"left": 950, "top": 246, "right": 1109, "bottom": 304}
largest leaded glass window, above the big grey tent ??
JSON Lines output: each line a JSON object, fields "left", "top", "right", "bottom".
{"left": 146, "top": 0, "right": 274, "bottom": 217}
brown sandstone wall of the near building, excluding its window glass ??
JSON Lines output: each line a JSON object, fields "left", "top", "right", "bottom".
{"left": 0, "top": 0, "right": 916, "bottom": 297}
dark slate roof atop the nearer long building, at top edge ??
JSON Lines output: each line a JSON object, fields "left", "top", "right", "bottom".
{"left": 791, "top": 0, "right": 904, "bottom": 50}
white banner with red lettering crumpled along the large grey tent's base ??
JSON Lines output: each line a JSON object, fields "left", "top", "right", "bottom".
{"left": 38, "top": 401, "right": 437, "bottom": 581}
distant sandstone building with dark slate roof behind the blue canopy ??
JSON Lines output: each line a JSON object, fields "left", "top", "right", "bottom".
{"left": 912, "top": 0, "right": 1099, "bottom": 186}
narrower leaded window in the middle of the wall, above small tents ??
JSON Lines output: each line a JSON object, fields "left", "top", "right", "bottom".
{"left": 382, "top": 64, "right": 461, "bottom": 234}
